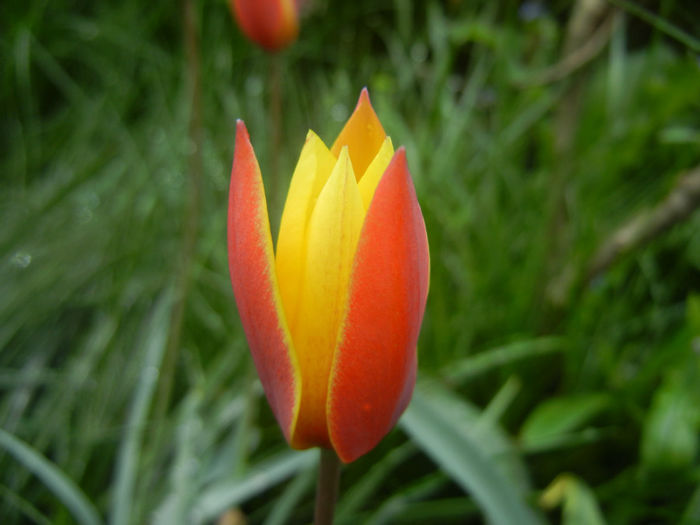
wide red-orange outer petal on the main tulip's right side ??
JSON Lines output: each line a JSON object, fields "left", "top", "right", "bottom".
{"left": 326, "top": 148, "right": 430, "bottom": 462}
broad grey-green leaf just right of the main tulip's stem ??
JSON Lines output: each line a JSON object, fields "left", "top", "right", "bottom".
{"left": 400, "top": 383, "right": 541, "bottom": 525}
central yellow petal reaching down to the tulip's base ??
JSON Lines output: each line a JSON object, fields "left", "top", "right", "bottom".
{"left": 290, "top": 148, "right": 364, "bottom": 447}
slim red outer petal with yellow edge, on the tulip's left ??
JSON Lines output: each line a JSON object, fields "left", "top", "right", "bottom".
{"left": 228, "top": 120, "right": 301, "bottom": 441}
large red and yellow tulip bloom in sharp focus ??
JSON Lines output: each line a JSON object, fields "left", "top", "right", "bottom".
{"left": 228, "top": 89, "right": 430, "bottom": 463}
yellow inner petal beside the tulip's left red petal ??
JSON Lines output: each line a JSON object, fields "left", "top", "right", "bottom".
{"left": 275, "top": 131, "right": 336, "bottom": 332}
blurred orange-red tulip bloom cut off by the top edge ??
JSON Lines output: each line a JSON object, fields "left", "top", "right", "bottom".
{"left": 229, "top": 0, "right": 300, "bottom": 51}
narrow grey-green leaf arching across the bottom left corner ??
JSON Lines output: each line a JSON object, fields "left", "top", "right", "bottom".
{"left": 0, "top": 428, "right": 102, "bottom": 525}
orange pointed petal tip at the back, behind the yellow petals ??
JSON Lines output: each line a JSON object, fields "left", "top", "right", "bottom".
{"left": 331, "top": 88, "right": 386, "bottom": 181}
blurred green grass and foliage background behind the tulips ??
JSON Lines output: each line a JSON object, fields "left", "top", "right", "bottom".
{"left": 0, "top": 0, "right": 700, "bottom": 525}
